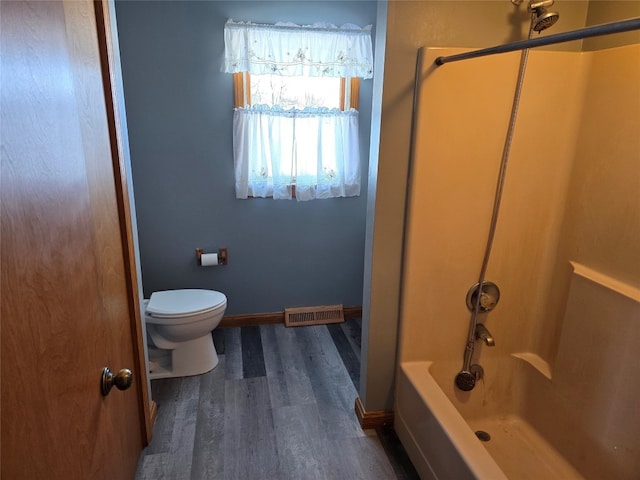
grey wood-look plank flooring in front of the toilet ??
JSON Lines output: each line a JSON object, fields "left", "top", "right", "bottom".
{"left": 136, "top": 319, "right": 419, "bottom": 480}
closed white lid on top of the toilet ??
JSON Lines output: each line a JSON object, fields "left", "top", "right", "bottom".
{"left": 147, "top": 288, "right": 227, "bottom": 316}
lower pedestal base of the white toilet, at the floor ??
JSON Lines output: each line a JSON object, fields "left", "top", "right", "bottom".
{"left": 149, "top": 333, "right": 218, "bottom": 380}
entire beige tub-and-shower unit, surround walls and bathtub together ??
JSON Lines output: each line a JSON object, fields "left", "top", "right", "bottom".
{"left": 395, "top": 45, "right": 640, "bottom": 479}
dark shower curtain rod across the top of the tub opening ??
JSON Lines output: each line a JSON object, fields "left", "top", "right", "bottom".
{"left": 434, "top": 17, "right": 640, "bottom": 66}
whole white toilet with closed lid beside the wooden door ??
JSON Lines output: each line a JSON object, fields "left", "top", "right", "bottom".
{"left": 144, "top": 289, "right": 227, "bottom": 380}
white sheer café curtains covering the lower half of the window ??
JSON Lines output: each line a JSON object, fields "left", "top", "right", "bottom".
{"left": 233, "top": 107, "right": 360, "bottom": 201}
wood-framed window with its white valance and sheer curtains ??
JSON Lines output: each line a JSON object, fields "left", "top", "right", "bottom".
{"left": 223, "top": 20, "right": 372, "bottom": 200}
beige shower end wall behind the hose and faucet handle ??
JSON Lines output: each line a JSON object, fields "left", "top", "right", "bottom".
{"left": 401, "top": 49, "right": 584, "bottom": 360}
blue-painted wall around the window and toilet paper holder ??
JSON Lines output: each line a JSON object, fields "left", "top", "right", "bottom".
{"left": 116, "top": 1, "right": 376, "bottom": 314}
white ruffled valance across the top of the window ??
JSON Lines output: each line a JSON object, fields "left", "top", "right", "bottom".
{"left": 222, "top": 20, "right": 373, "bottom": 78}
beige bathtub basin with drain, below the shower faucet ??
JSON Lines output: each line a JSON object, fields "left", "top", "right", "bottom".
{"left": 395, "top": 354, "right": 640, "bottom": 480}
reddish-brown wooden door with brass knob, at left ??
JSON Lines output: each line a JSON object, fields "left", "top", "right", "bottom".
{"left": 0, "top": 0, "right": 148, "bottom": 480}
